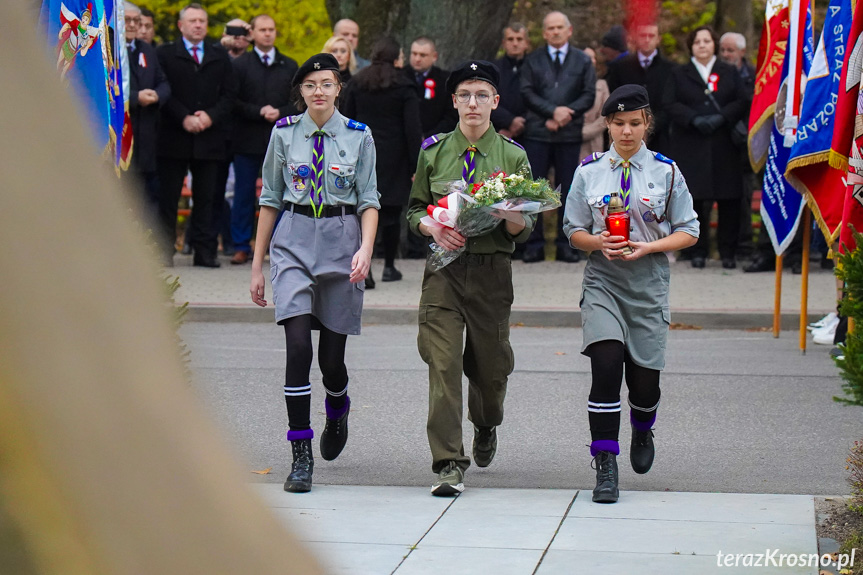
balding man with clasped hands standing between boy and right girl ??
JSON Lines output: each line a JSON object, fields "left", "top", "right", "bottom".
{"left": 521, "top": 12, "right": 596, "bottom": 262}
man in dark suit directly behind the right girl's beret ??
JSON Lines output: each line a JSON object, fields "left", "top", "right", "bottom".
{"left": 605, "top": 24, "right": 674, "bottom": 155}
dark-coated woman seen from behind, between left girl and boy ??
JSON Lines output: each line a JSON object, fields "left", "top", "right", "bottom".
{"left": 339, "top": 38, "right": 422, "bottom": 282}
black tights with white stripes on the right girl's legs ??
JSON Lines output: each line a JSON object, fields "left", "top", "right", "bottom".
{"left": 585, "top": 339, "right": 660, "bottom": 441}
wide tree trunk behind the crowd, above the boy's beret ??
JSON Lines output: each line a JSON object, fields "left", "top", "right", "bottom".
{"left": 326, "top": 0, "right": 514, "bottom": 68}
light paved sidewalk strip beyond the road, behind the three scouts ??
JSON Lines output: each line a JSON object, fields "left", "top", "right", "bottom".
{"left": 168, "top": 255, "right": 836, "bottom": 329}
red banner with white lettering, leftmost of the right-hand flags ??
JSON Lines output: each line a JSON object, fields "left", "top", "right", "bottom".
{"left": 749, "top": 0, "right": 789, "bottom": 172}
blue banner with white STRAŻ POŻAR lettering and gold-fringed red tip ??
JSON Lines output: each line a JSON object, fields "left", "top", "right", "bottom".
{"left": 785, "top": 0, "right": 852, "bottom": 244}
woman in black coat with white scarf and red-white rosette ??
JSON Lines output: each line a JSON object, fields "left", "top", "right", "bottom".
{"left": 663, "top": 26, "right": 749, "bottom": 269}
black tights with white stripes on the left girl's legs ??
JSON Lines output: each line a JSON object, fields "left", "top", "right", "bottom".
{"left": 282, "top": 315, "right": 348, "bottom": 431}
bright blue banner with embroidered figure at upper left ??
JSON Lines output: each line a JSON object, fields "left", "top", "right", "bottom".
{"left": 40, "top": 0, "right": 111, "bottom": 156}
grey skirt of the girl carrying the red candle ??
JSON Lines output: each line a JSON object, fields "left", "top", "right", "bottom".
{"left": 580, "top": 251, "right": 671, "bottom": 370}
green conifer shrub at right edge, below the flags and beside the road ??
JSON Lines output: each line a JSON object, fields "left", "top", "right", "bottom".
{"left": 833, "top": 226, "right": 863, "bottom": 406}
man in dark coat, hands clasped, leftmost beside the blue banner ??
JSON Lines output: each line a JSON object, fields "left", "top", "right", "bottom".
{"left": 124, "top": 2, "right": 171, "bottom": 219}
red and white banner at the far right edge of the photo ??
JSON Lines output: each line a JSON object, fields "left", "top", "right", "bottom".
{"left": 830, "top": 0, "right": 863, "bottom": 252}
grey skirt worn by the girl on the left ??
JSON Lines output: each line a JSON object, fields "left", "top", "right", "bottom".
{"left": 270, "top": 209, "right": 365, "bottom": 335}
